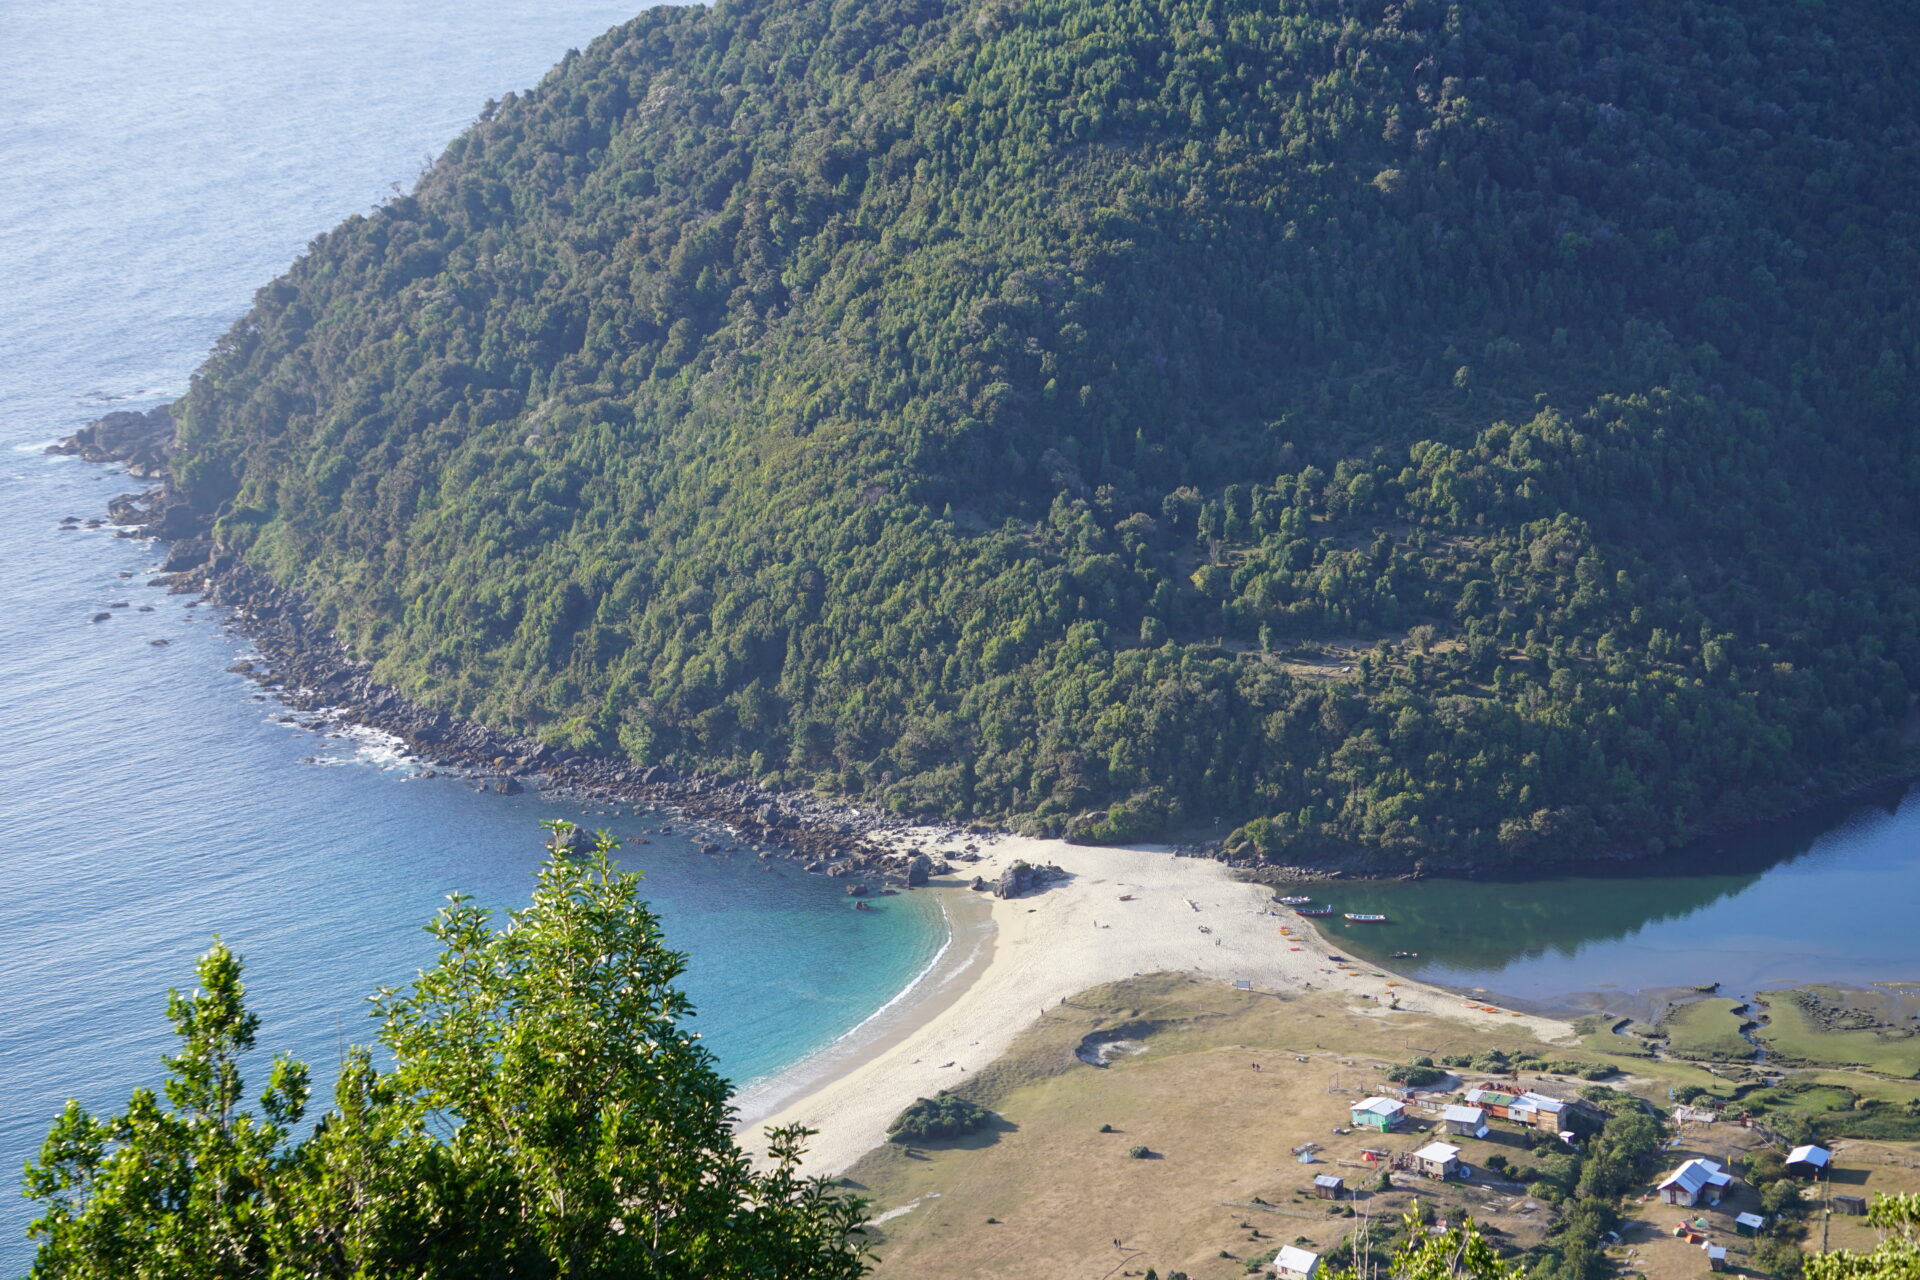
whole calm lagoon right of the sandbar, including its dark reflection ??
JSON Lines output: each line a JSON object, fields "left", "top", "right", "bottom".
{"left": 1290, "top": 791, "right": 1920, "bottom": 1004}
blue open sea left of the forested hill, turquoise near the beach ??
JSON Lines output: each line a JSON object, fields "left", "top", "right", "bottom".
{"left": 0, "top": 0, "right": 947, "bottom": 1274}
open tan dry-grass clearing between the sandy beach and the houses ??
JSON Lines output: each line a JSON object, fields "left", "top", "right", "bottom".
{"left": 849, "top": 975, "right": 1571, "bottom": 1280}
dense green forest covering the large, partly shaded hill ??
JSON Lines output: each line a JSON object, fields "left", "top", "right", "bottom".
{"left": 161, "top": 0, "right": 1920, "bottom": 865}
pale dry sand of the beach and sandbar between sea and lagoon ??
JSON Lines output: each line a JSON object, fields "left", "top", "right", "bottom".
{"left": 725, "top": 833, "right": 1569, "bottom": 1174}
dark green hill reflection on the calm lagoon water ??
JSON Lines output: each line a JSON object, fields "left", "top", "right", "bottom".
{"left": 1325, "top": 787, "right": 1920, "bottom": 971}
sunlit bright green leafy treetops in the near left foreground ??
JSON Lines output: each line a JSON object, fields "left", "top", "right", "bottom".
{"left": 27, "top": 821, "right": 866, "bottom": 1280}
